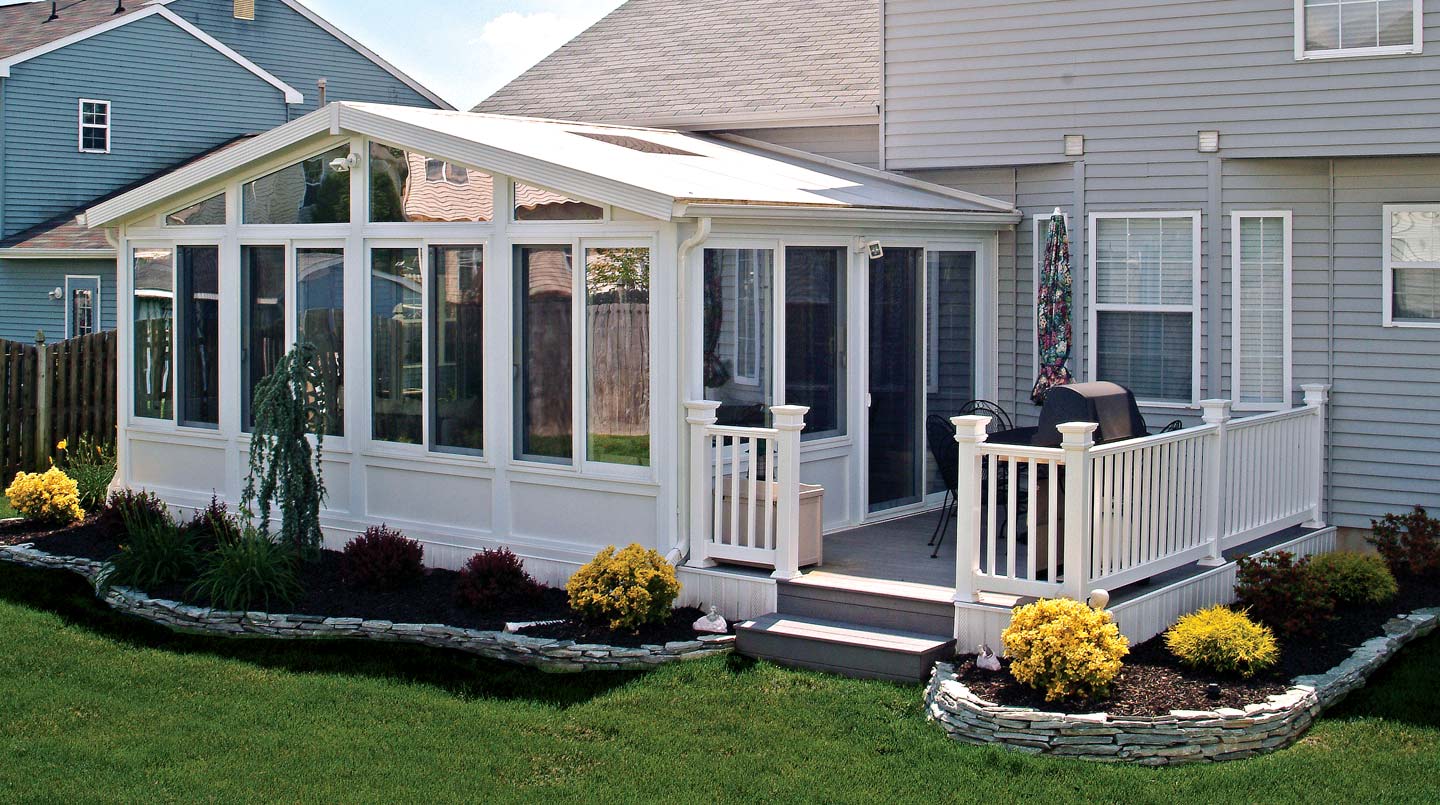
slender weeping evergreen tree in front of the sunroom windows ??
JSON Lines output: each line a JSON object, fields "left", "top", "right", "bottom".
{"left": 240, "top": 343, "right": 328, "bottom": 559}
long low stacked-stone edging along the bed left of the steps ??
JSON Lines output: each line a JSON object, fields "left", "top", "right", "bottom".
{"left": 0, "top": 546, "right": 734, "bottom": 673}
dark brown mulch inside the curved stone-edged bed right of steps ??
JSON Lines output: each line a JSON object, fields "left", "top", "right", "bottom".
{"left": 956, "top": 577, "right": 1440, "bottom": 716}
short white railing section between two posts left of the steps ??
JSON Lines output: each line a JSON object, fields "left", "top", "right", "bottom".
{"left": 685, "top": 402, "right": 809, "bottom": 579}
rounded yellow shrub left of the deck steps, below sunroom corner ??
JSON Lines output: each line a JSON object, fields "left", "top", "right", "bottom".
{"left": 564, "top": 544, "right": 680, "bottom": 631}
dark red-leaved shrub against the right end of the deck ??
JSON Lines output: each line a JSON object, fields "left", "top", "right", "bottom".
{"left": 1236, "top": 550, "right": 1335, "bottom": 635}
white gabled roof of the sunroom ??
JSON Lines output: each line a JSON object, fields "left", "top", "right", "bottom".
{"left": 86, "top": 102, "right": 1015, "bottom": 226}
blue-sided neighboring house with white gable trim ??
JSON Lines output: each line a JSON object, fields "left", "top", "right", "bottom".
{"left": 0, "top": 0, "right": 448, "bottom": 341}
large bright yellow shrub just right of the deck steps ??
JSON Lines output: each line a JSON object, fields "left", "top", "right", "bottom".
{"left": 1001, "top": 598, "right": 1130, "bottom": 701}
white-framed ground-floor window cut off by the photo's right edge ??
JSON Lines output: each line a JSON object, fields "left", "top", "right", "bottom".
{"left": 1382, "top": 204, "right": 1440, "bottom": 327}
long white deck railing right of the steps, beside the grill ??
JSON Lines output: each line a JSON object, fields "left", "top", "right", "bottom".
{"left": 953, "top": 386, "right": 1328, "bottom": 602}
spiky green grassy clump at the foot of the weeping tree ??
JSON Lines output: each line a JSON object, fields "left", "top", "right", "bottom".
{"left": 190, "top": 527, "right": 301, "bottom": 612}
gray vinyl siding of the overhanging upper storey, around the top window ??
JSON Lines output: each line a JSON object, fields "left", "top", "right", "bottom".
{"left": 884, "top": 0, "right": 1440, "bottom": 169}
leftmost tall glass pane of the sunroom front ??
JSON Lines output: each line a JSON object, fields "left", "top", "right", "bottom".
{"left": 132, "top": 249, "right": 174, "bottom": 419}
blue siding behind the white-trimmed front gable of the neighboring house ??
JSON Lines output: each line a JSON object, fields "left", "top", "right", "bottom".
{"left": 170, "top": 0, "right": 435, "bottom": 117}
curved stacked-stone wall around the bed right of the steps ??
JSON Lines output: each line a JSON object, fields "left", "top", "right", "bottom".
{"left": 924, "top": 608, "right": 1440, "bottom": 766}
